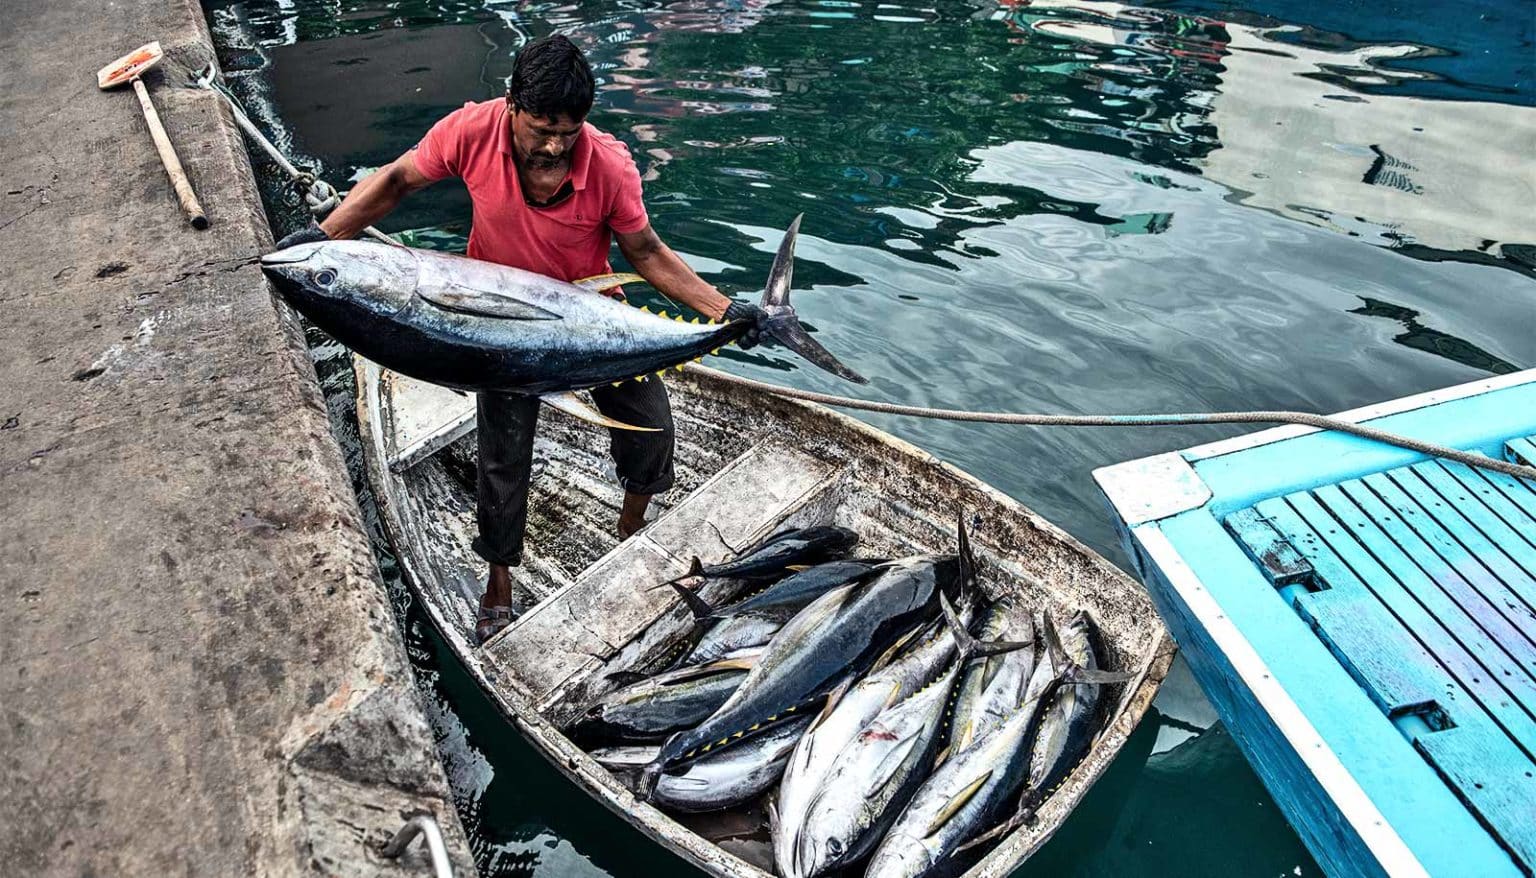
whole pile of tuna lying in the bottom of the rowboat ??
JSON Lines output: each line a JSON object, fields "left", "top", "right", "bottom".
{"left": 568, "top": 523, "right": 1126, "bottom": 878}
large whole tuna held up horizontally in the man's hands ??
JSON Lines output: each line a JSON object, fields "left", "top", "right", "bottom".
{"left": 261, "top": 216, "right": 865, "bottom": 425}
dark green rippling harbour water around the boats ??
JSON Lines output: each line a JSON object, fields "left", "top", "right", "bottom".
{"left": 207, "top": 0, "right": 1536, "bottom": 876}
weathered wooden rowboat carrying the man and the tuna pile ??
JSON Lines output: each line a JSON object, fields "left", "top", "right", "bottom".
{"left": 356, "top": 359, "right": 1174, "bottom": 878}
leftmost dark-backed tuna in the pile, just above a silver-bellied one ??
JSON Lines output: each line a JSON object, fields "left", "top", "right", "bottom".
{"left": 570, "top": 651, "right": 760, "bottom": 741}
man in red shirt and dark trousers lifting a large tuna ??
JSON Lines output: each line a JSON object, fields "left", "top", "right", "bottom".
{"left": 278, "top": 35, "right": 768, "bottom": 643}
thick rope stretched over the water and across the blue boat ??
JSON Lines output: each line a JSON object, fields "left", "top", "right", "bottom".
{"left": 688, "top": 364, "right": 1536, "bottom": 480}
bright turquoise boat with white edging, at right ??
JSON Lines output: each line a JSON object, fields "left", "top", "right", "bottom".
{"left": 1095, "top": 370, "right": 1536, "bottom": 876}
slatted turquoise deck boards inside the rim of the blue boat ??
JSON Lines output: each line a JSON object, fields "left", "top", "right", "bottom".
{"left": 1226, "top": 441, "right": 1536, "bottom": 873}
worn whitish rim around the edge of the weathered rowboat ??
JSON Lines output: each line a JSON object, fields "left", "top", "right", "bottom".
{"left": 353, "top": 356, "right": 1177, "bottom": 878}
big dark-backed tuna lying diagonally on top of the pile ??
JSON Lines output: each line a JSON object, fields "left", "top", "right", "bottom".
{"left": 647, "top": 522, "right": 974, "bottom": 798}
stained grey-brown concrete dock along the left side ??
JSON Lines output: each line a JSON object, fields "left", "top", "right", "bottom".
{"left": 0, "top": 0, "right": 473, "bottom": 876}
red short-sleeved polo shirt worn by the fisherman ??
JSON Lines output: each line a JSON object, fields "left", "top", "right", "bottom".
{"left": 416, "top": 98, "right": 650, "bottom": 281}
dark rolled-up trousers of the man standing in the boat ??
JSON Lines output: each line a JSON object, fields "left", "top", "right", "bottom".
{"left": 475, "top": 378, "right": 673, "bottom": 566}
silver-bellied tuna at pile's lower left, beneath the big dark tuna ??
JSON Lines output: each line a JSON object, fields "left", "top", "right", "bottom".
{"left": 591, "top": 717, "right": 813, "bottom": 814}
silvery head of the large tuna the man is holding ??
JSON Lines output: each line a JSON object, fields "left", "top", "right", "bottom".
{"left": 261, "top": 241, "right": 418, "bottom": 316}
